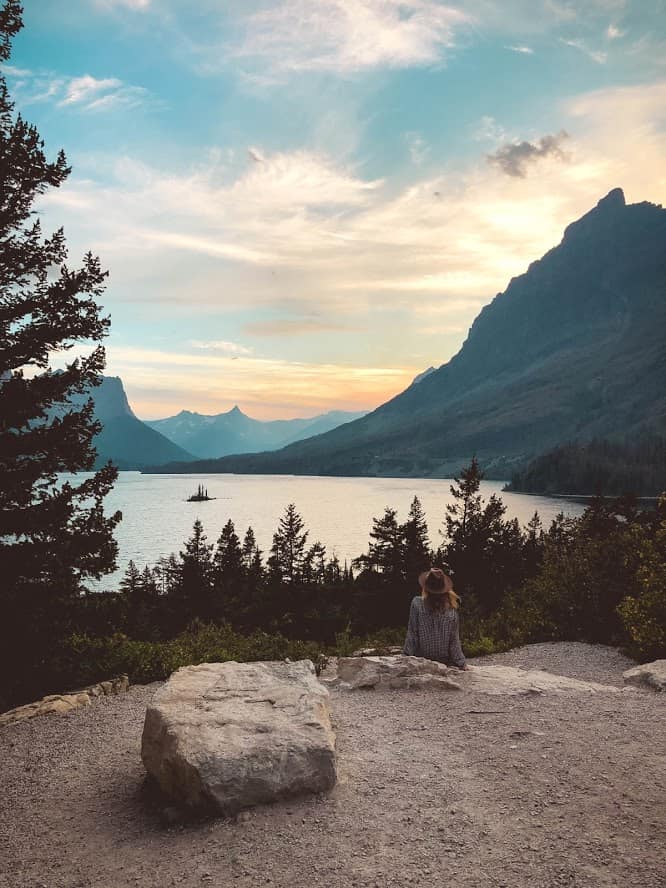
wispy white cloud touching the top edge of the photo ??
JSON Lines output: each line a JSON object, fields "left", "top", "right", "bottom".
{"left": 231, "top": 0, "right": 469, "bottom": 73}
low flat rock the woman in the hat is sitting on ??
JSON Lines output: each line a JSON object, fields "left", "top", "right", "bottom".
{"left": 338, "top": 654, "right": 459, "bottom": 690}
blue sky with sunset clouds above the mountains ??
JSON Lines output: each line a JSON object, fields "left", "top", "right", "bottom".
{"left": 3, "top": 0, "right": 666, "bottom": 419}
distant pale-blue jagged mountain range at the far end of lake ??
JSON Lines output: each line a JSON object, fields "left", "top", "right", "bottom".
{"left": 146, "top": 407, "right": 364, "bottom": 457}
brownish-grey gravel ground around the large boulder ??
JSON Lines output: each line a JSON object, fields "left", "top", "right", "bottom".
{"left": 0, "top": 644, "right": 666, "bottom": 888}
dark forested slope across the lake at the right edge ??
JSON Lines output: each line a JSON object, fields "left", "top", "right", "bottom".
{"left": 507, "top": 436, "right": 666, "bottom": 496}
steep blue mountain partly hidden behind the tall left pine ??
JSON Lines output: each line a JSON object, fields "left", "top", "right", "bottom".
{"left": 71, "top": 376, "right": 192, "bottom": 470}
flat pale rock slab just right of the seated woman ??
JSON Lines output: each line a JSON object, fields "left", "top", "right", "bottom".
{"left": 459, "top": 666, "right": 622, "bottom": 697}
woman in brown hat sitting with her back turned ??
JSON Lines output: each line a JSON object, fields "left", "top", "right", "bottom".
{"left": 402, "top": 567, "right": 467, "bottom": 669}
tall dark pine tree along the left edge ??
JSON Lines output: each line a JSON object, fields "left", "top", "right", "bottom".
{"left": 0, "top": 0, "right": 120, "bottom": 708}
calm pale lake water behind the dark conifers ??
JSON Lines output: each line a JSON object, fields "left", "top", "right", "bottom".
{"left": 91, "top": 472, "right": 584, "bottom": 589}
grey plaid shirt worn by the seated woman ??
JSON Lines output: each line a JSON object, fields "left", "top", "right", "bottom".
{"left": 402, "top": 595, "right": 465, "bottom": 669}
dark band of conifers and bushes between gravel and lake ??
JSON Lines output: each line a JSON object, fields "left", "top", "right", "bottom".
{"left": 0, "top": 461, "right": 666, "bottom": 706}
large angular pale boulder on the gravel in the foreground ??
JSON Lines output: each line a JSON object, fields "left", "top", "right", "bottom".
{"left": 141, "top": 660, "right": 336, "bottom": 814}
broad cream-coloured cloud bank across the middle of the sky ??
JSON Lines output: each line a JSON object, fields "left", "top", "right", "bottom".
{"left": 41, "top": 81, "right": 666, "bottom": 406}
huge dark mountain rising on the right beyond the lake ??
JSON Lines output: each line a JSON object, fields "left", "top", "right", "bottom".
{"left": 144, "top": 189, "right": 666, "bottom": 477}
